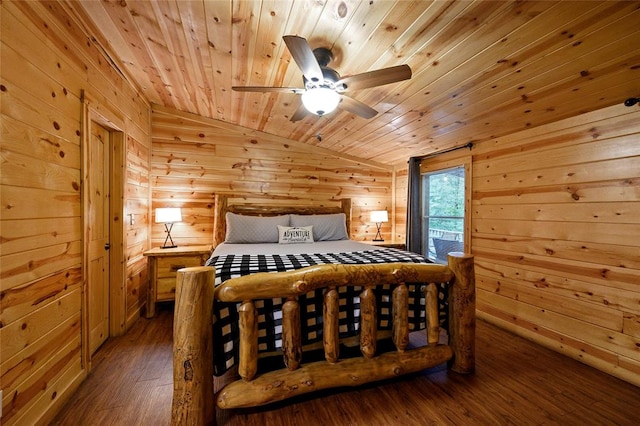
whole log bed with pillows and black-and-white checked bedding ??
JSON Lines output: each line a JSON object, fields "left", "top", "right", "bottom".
{"left": 172, "top": 195, "right": 475, "bottom": 424}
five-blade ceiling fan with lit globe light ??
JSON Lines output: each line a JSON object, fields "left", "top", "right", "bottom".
{"left": 232, "top": 35, "right": 411, "bottom": 122}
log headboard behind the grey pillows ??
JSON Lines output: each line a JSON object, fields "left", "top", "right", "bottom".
{"left": 213, "top": 194, "right": 351, "bottom": 247}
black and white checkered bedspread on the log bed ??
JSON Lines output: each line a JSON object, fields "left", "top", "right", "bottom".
{"left": 206, "top": 248, "right": 447, "bottom": 375}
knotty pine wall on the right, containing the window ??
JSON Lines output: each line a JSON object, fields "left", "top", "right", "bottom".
{"left": 396, "top": 103, "right": 640, "bottom": 386}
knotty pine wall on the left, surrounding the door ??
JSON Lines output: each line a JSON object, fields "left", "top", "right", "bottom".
{"left": 0, "top": 1, "right": 150, "bottom": 425}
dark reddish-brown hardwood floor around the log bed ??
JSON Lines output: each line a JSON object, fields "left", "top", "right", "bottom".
{"left": 53, "top": 305, "right": 640, "bottom": 426}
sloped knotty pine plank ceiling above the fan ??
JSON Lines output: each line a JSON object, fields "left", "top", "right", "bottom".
{"left": 65, "top": 0, "right": 640, "bottom": 164}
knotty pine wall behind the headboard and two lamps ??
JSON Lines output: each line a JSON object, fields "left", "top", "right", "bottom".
{"left": 151, "top": 106, "right": 393, "bottom": 246}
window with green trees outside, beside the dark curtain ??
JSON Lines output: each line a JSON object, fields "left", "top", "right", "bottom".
{"left": 422, "top": 166, "right": 465, "bottom": 263}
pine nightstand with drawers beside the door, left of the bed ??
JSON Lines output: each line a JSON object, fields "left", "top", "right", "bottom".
{"left": 144, "top": 246, "right": 211, "bottom": 318}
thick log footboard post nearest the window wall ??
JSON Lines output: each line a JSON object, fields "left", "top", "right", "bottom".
{"left": 448, "top": 252, "right": 476, "bottom": 374}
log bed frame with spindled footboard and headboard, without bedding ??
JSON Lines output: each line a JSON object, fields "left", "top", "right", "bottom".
{"left": 172, "top": 196, "right": 475, "bottom": 424}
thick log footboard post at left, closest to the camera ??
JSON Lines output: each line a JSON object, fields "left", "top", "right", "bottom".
{"left": 171, "top": 266, "right": 215, "bottom": 425}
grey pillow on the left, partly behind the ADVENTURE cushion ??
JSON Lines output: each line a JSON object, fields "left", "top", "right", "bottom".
{"left": 224, "top": 213, "right": 289, "bottom": 244}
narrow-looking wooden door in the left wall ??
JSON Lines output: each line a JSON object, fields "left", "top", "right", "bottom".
{"left": 85, "top": 122, "right": 110, "bottom": 354}
